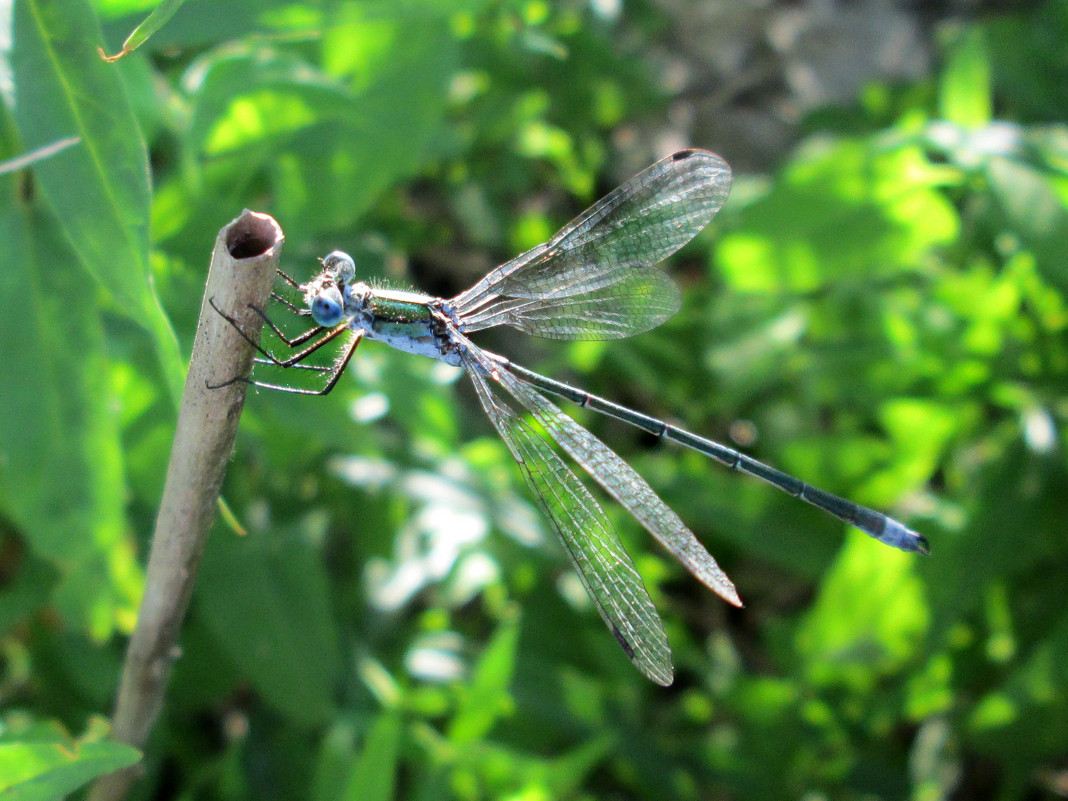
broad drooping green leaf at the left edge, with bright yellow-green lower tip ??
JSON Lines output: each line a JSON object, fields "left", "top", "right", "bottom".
{"left": 0, "top": 205, "right": 142, "bottom": 639}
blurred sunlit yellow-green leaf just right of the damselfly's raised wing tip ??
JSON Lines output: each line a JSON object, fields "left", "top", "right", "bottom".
{"left": 717, "top": 140, "right": 959, "bottom": 293}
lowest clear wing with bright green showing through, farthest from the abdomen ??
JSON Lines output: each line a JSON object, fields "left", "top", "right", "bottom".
{"left": 464, "top": 346, "right": 674, "bottom": 686}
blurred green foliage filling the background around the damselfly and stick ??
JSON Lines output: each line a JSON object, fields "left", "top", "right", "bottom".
{"left": 0, "top": 0, "right": 1068, "bottom": 801}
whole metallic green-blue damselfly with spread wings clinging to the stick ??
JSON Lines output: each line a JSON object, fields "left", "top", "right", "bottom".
{"left": 214, "top": 150, "right": 927, "bottom": 685}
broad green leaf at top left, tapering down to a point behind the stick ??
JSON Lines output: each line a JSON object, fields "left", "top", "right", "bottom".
{"left": 12, "top": 0, "right": 185, "bottom": 401}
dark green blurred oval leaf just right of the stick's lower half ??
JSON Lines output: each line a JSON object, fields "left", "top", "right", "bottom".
{"left": 197, "top": 529, "right": 341, "bottom": 724}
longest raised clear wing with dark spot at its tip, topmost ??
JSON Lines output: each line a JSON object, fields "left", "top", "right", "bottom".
{"left": 451, "top": 150, "right": 731, "bottom": 341}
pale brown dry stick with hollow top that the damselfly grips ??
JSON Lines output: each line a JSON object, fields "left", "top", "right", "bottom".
{"left": 89, "top": 210, "right": 284, "bottom": 801}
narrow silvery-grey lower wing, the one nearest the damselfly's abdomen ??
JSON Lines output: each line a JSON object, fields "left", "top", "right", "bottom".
{"left": 494, "top": 352, "right": 741, "bottom": 607}
